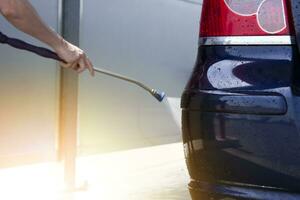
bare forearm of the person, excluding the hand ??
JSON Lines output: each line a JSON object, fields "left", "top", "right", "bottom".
{"left": 0, "top": 0, "right": 62, "bottom": 49}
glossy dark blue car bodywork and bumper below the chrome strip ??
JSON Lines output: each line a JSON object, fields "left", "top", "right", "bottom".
{"left": 182, "top": 46, "right": 300, "bottom": 200}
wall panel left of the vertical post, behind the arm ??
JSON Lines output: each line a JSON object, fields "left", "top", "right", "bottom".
{"left": 0, "top": 0, "right": 59, "bottom": 166}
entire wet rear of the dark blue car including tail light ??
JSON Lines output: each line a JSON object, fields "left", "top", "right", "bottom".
{"left": 181, "top": 0, "right": 300, "bottom": 200}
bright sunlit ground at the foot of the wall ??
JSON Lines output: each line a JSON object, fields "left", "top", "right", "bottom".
{"left": 0, "top": 143, "right": 190, "bottom": 200}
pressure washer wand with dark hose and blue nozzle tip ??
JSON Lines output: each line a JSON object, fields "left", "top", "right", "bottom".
{"left": 0, "top": 32, "right": 166, "bottom": 102}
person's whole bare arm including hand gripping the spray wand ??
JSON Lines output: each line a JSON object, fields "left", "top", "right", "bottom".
{"left": 0, "top": 0, "right": 94, "bottom": 75}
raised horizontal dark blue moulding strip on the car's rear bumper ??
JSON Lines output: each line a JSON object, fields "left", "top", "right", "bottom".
{"left": 181, "top": 90, "right": 287, "bottom": 115}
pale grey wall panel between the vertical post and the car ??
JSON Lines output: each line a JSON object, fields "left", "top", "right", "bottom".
{"left": 79, "top": 0, "right": 201, "bottom": 152}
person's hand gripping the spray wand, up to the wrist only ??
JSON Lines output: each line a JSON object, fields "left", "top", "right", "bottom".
{"left": 54, "top": 39, "right": 95, "bottom": 76}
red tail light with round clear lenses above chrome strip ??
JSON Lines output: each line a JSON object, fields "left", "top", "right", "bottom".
{"left": 200, "top": 0, "right": 290, "bottom": 37}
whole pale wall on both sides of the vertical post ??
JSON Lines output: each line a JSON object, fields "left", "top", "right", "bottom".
{"left": 0, "top": 0, "right": 202, "bottom": 198}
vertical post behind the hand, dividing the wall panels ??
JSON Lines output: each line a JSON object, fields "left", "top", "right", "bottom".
{"left": 59, "top": 0, "right": 81, "bottom": 190}
